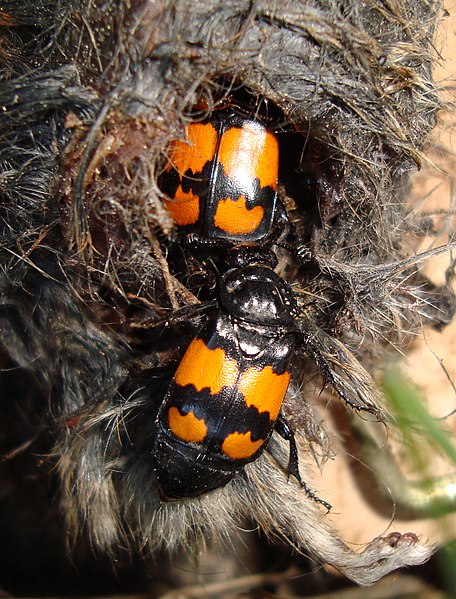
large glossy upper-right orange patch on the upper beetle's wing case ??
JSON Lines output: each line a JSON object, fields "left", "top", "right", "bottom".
{"left": 218, "top": 123, "right": 279, "bottom": 190}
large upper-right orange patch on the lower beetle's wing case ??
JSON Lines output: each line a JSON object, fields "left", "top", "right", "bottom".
{"left": 239, "top": 366, "right": 290, "bottom": 420}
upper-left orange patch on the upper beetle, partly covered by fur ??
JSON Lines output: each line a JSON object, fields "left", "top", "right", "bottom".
{"left": 167, "top": 123, "right": 218, "bottom": 176}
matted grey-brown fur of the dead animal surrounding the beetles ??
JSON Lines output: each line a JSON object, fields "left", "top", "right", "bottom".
{"left": 0, "top": 0, "right": 453, "bottom": 584}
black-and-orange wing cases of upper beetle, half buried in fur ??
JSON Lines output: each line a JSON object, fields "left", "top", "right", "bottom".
{"left": 159, "top": 107, "right": 286, "bottom": 244}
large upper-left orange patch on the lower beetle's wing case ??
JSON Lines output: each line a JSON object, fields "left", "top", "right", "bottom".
{"left": 174, "top": 339, "right": 238, "bottom": 395}
